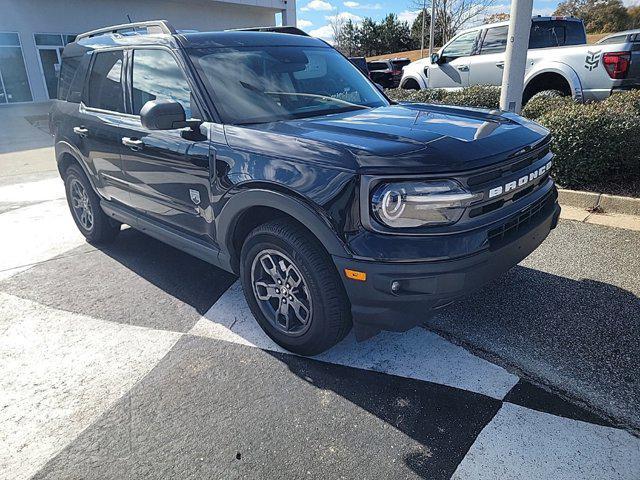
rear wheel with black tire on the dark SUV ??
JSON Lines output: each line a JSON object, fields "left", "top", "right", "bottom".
{"left": 64, "top": 165, "right": 120, "bottom": 243}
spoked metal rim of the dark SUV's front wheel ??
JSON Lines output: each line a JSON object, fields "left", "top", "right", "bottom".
{"left": 251, "top": 249, "right": 313, "bottom": 337}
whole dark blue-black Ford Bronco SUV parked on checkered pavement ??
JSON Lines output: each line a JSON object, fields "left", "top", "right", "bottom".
{"left": 51, "top": 21, "right": 560, "bottom": 355}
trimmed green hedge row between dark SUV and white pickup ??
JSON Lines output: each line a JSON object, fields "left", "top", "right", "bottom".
{"left": 387, "top": 86, "right": 640, "bottom": 196}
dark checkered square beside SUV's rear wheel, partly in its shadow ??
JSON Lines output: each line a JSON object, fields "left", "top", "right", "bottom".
{"left": 0, "top": 229, "right": 236, "bottom": 332}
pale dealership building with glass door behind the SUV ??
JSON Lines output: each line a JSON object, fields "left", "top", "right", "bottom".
{"left": 0, "top": 0, "right": 296, "bottom": 106}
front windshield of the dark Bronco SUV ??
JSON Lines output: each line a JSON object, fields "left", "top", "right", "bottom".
{"left": 190, "top": 46, "right": 388, "bottom": 124}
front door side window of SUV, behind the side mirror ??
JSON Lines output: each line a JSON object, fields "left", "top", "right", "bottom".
{"left": 132, "top": 49, "right": 192, "bottom": 118}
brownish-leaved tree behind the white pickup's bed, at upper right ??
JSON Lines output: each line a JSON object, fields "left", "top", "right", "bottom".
{"left": 553, "top": 0, "right": 630, "bottom": 33}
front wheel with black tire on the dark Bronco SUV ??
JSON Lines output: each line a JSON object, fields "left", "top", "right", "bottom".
{"left": 240, "top": 220, "right": 351, "bottom": 356}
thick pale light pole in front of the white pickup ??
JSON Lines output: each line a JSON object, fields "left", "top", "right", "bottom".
{"left": 500, "top": 0, "right": 533, "bottom": 113}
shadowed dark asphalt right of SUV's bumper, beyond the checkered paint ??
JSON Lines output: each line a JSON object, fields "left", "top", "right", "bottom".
{"left": 427, "top": 266, "right": 640, "bottom": 430}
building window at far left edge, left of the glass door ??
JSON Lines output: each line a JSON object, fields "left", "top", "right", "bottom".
{"left": 0, "top": 32, "right": 33, "bottom": 104}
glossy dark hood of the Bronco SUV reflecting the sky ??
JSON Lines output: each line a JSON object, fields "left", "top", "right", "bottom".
{"left": 226, "top": 104, "right": 549, "bottom": 173}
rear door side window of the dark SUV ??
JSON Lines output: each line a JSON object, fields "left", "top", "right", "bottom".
{"left": 85, "top": 50, "right": 125, "bottom": 113}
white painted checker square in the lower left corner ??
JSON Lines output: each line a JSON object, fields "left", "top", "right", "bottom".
{"left": 0, "top": 293, "right": 181, "bottom": 480}
